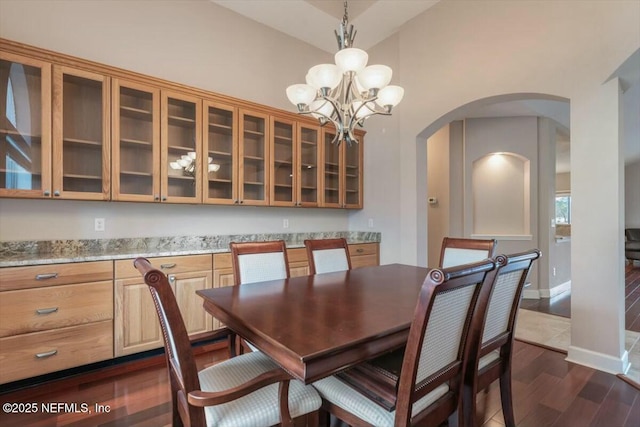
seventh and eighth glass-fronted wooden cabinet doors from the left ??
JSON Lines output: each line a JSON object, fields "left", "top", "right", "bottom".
{"left": 270, "top": 116, "right": 320, "bottom": 207}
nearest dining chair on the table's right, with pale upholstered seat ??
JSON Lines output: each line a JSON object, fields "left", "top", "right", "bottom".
{"left": 313, "top": 259, "right": 495, "bottom": 427}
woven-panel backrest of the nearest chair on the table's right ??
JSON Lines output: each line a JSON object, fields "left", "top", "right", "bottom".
{"left": 395, "top": 259, "right": 495, "bottom": 425}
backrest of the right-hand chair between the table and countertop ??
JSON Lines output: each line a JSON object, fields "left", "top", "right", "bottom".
{"left": 304, "top": 238, "right": 351, "bottom": 274}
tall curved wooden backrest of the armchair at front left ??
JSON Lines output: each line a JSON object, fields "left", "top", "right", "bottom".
{"left": 133, "top": 258, "right": 206, "bottom": 426}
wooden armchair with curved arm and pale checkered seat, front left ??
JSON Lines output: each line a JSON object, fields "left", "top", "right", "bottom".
{"left": 134, "top": 258, "right": 322, "bottom": 427}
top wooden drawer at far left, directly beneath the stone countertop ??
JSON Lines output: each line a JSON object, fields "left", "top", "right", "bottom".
{"left": 0, "top": 261, "right": 113, "bottom": 291}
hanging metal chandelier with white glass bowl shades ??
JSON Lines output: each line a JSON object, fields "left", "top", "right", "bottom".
{"left": 287, "top": 1, "right": 404, "bottom": 145}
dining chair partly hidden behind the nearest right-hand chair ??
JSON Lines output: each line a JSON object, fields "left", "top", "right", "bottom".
{"left": 463, "top": 249, "right": 541, "bottom": 427}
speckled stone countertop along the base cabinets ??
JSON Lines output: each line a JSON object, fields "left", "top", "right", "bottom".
{"left": 0, "top": 231, "right": 381, "bottom": 268}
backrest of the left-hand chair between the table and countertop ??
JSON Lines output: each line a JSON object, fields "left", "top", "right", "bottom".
{"left": 229, "top": 240, "right": 289, "bottom": 285}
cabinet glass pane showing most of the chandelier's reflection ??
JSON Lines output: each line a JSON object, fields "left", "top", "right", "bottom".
{"left": 164, "top": 98, "right": 199, "bottom": 197}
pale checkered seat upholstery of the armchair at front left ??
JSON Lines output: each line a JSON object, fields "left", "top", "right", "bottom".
{"left": 198, "top": 353, "right": 322, "bottom": 427}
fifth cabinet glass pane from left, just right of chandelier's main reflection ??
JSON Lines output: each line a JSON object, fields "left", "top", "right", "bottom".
{"left": 206, "top": 107, "right": 234, "bottom": 200}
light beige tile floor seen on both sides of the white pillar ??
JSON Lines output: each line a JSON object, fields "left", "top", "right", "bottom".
{"left": 516, "top": 309, "right": 640, "bottom": 384}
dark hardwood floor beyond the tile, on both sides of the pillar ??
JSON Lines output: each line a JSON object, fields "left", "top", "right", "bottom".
{"left": 520, "top": 264, "right": 640, "bottom": 332}
